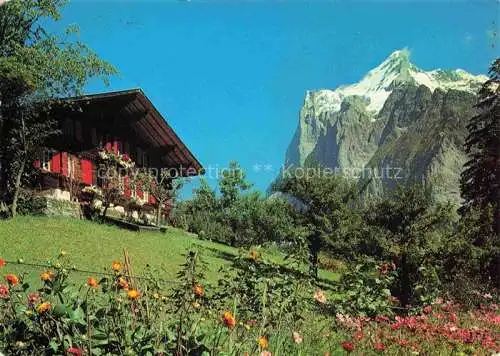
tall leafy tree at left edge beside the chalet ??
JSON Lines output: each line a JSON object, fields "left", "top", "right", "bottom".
{"left": 0, "top": 0, "right": 116, "bottom": 216}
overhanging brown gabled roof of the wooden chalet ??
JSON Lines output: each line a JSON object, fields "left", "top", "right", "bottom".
{"left": 67, "top": 88, "right": 204, "bottom": 176}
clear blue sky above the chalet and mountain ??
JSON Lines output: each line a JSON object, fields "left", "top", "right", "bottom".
{"left": 53, "top": 0, "right": 500, "bottom": 196}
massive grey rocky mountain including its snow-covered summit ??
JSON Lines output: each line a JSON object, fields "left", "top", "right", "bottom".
{"left": 285, "top": 50, "right": 487, "bottom": 203}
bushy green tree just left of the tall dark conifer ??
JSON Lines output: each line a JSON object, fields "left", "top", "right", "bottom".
{"left": 365, "top": 186, "right": 453, "bottom": 307}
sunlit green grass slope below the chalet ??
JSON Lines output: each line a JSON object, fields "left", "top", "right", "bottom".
{"left": 0, "top": 216, "right": 338, "bottom": 282}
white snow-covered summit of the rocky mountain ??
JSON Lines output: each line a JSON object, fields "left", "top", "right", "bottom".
{"left": 306, "top": 49, "right": 487, "bottom": 115}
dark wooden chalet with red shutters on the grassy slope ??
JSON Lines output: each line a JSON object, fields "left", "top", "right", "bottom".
{"left": 35, "top": 89, "right": 203, "bottom": 220}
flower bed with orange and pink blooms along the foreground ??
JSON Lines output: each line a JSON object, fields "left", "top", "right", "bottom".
{"left": 0, "top": 245, "right": 500, "bottom": 356}
